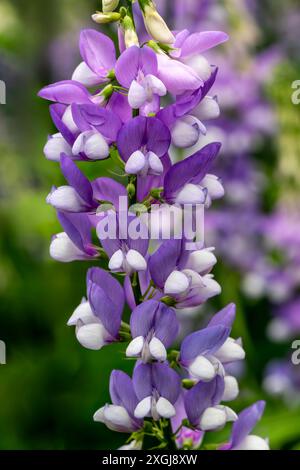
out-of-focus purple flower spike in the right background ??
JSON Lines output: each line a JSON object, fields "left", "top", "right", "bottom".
{"left": 161, "top": 0, "right": 300, "bottom": 405}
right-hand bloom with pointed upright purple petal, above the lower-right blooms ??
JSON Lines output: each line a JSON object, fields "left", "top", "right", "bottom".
{"left": 179, "top": 304, "right": 245, "bottom": 382}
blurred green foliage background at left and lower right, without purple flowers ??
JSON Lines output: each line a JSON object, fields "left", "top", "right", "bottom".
{"left": 0, "top": 0, "right": 300, "bottom": 449}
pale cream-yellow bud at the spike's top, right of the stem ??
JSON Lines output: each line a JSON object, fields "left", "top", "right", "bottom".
{"left": 139, "top": 0, "right": 175, "bottom": 44}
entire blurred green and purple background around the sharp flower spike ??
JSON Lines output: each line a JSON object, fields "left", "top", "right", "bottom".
{"left": 0, "top": 0, "right": 300, "bottom": 450}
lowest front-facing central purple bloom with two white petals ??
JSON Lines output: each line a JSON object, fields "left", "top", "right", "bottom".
{"left": 133, "top": 362, "right": 180, "bottom": 421}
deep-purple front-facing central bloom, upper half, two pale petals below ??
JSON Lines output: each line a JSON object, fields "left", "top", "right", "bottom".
{"left": 117, "top": 116, "right": 171, "bottom": 200}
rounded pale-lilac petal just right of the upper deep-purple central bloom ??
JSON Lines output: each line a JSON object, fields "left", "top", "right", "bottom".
{"left": 171, "top": 116, "right": 204, "bottom": 148}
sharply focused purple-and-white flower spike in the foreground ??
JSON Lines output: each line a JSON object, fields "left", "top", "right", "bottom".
{"left": 40, "top": 0, "right": 268, "bottom": 450}
